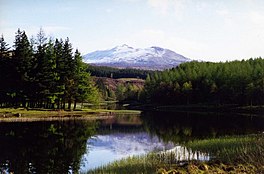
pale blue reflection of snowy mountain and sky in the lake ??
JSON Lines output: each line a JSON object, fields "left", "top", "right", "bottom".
{"left": 81, "top": 132, "right": 174, "bottom": 171}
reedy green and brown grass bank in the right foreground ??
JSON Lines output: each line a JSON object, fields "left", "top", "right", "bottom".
{"left": 88, "top": 135, "right": 264, "bottom": 174}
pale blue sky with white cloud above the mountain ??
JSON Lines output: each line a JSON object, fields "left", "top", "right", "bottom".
{"left": 0, "top": 0, "right": 264, "bottom": 61}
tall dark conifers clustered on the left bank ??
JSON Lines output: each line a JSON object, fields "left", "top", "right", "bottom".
{"left": 0, "top": 29, "right": 99, "bottom": 109}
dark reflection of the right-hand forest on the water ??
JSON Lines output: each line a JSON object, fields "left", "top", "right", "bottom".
{"left": 142, "top": 112, "right": 264, "bottom": 143}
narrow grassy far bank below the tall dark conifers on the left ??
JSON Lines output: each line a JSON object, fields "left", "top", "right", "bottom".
{"left": 0, "top": 108, "right": 141, "bottom": 122}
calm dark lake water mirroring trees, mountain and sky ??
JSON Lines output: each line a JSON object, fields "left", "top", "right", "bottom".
{"left": 0, "top": 112, "right": 264, "bottom": 173}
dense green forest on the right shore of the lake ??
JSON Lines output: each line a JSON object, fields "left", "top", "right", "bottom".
{"left": 144, "top": 58, "right": 264, "bottom": 105}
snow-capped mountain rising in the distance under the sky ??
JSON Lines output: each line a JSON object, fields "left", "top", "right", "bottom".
{"left": 83, "top": 44, "right": 190, "bottom": 70}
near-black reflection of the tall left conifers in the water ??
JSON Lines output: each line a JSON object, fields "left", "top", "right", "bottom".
{"left": 0, "top": 120, "right": 98, "bottom": 173}
